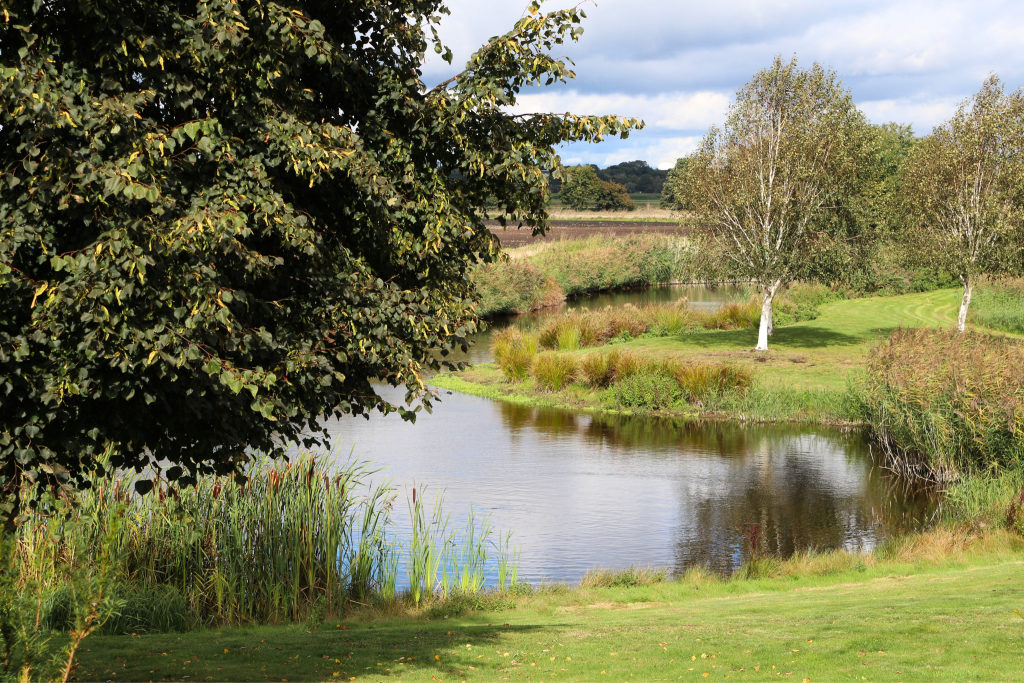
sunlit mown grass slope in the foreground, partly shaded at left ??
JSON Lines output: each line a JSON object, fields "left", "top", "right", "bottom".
{"left": 76, "top": 543, "right": 1024, "bottom": 681}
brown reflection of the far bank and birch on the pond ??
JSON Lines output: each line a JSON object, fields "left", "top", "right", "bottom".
{"left": 501, "top": 403, "right": 934, "bottom": 571}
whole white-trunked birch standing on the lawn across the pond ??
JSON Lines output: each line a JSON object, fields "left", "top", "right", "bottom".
{"left": 677, "top": 57, "right": 865, "bottom": 350}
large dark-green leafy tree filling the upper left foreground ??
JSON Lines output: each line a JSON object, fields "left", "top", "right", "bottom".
{"left": 0, "top": 0, "right": 640, "bottom": 524}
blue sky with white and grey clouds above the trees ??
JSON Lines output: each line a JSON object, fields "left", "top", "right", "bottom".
{"left": 424, "top": 0, "right": 1024, "bottom": 168}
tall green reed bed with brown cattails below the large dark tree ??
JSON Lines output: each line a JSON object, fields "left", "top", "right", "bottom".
{"left": 9, "top": 453, "right": 518, "bottom": 632}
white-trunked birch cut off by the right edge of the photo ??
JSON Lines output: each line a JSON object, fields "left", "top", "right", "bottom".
{"left": 901, "top": 75, "right": 1024, "bottom": 332}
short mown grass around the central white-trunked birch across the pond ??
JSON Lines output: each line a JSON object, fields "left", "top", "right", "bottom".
{"left": 432, "top": 289, "right": 959, "bottom": 423}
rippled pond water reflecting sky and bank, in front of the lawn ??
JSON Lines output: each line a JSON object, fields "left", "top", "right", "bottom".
{"left": 321, "top": 291, "right": 935, "bottom": 583}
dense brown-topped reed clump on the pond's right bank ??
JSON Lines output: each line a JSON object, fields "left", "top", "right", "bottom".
{"left": 863, "top": 329, "right": 1024, "bottom": 480}
